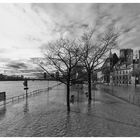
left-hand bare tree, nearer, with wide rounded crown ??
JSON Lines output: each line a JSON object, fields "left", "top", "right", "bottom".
{"left": 35, "top": 38, "right": 82, "bottom": 111}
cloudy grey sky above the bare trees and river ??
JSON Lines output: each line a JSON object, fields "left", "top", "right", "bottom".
{"left": 0, "top": 3, "right": 140, "bottom": 76}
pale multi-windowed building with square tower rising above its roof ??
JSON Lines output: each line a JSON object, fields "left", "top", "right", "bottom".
{"left": 112, "top": 49, "right": 133, "bottom": 85}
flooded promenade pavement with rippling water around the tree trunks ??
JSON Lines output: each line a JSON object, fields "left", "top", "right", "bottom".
{"left": 0, "top": 85, "right": 140, "bottom": 137}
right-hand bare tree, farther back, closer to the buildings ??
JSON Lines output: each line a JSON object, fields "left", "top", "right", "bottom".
{"left": 81, "top": 26, "right": 119, "bottom": 101}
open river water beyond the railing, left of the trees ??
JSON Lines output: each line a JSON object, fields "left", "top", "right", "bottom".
{"left": 0, "top": 81, "right": 57, "bottom": 98}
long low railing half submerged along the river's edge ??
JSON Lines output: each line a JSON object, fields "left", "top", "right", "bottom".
{"left": 0, "top": 83, "right": 61, "bottom": 106}
